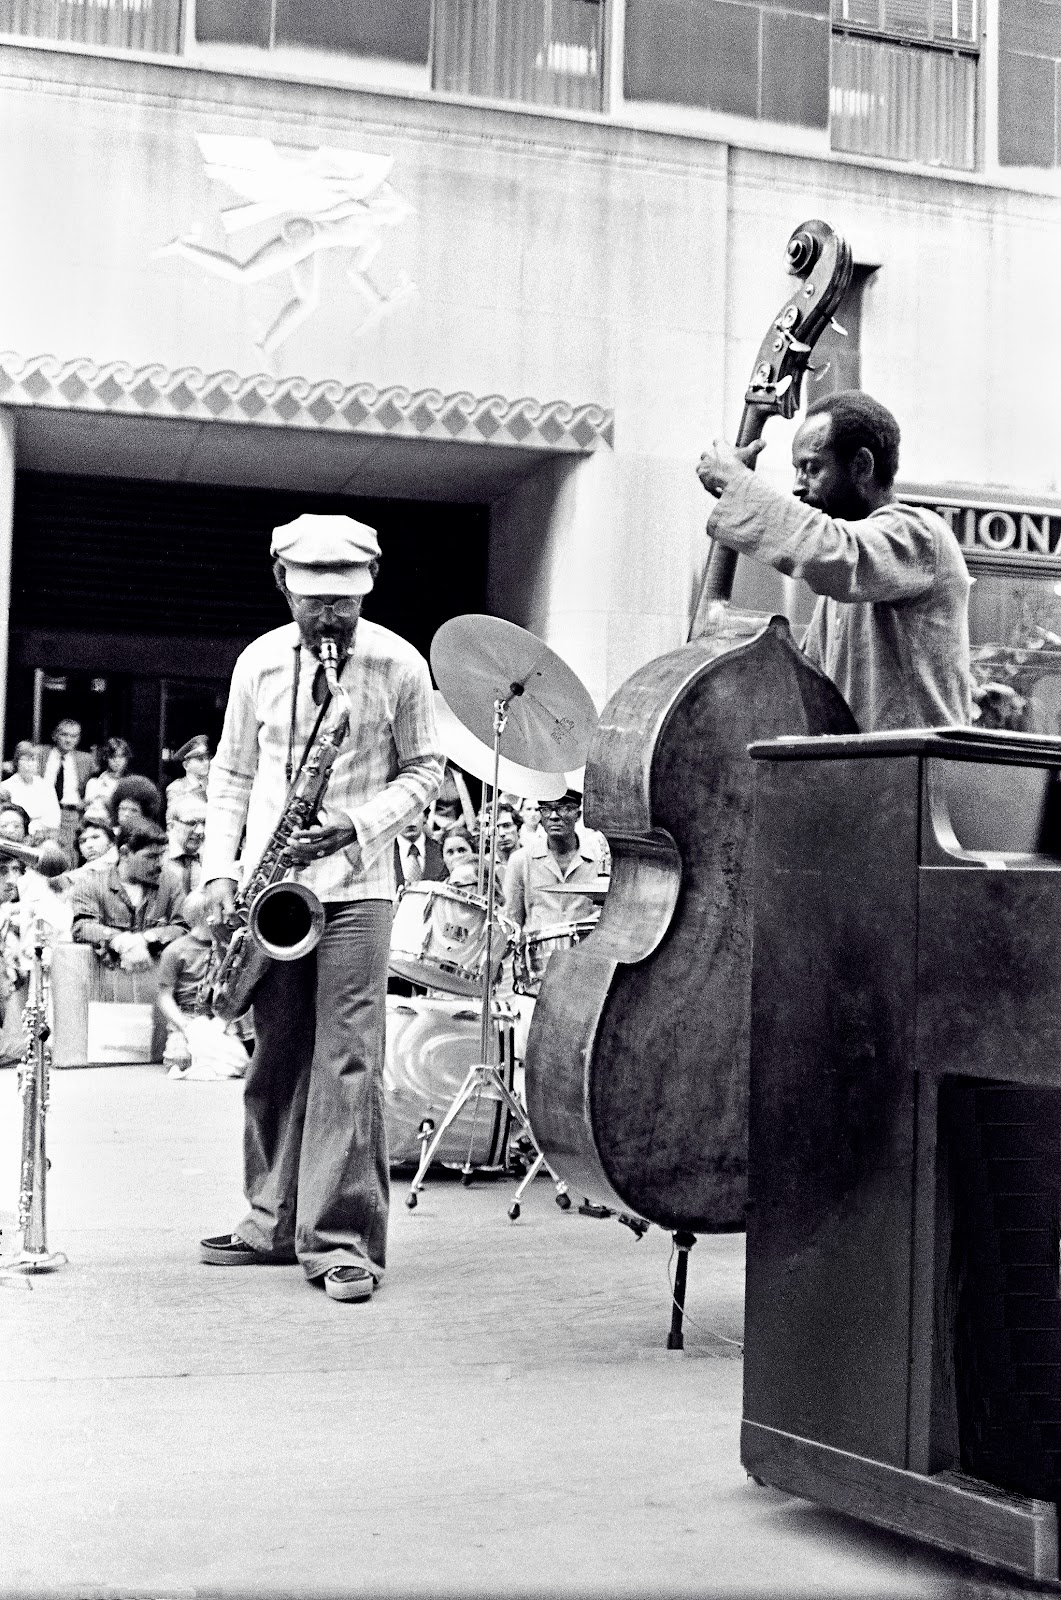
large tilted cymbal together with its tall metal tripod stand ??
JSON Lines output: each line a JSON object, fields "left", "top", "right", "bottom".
{"left": 405, "top": 616, "right": 597, "bottom": 1214}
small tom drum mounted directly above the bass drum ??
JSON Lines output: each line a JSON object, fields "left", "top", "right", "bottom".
{"left": 390, "top": 878, "right": 512, "bottom": 997}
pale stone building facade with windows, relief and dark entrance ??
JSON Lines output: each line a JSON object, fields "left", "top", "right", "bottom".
{"left": 0, "top": 0, "right": 1061, "bottom": 771}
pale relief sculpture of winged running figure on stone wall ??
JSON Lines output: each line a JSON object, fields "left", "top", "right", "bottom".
{"left": 154, "top": 133, "right": 414, "bottom": 354}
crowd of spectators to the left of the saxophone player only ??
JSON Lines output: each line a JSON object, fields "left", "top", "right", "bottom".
{"left": 0, "top": 718, "right": 242, "bottom": 1075}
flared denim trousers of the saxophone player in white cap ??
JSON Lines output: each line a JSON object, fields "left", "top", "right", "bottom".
{"left": 237, "top": 899, "right": 392, "bottom": 1278}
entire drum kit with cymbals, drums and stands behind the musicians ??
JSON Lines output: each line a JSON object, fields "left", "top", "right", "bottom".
{"left": 386, "top": 614, "right": 608, "bottom": 1218}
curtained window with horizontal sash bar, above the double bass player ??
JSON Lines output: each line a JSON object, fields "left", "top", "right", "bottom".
{"left": 829, "top": 0, "right": 979, "bottom": 171}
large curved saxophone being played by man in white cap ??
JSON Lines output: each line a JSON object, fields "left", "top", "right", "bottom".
{"left": 200, "top": 638, "right": 350, "bottom": 1022}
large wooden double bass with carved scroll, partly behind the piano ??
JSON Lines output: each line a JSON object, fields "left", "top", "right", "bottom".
{"left": 525, "top": 221, "right": 858, "bottom": 1235}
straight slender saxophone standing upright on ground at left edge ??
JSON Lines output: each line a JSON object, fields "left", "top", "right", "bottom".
{"left": 11, "top": 918, "right": 66, "bottom": 1272}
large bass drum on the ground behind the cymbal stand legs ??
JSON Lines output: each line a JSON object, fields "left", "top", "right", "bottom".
{"left": 382, "top": 995, "right": 514, "bottom": 1168}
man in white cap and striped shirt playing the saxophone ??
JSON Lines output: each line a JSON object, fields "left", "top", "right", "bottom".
{"left": 200, "top": 515, "right": 442, "bottom": 1301}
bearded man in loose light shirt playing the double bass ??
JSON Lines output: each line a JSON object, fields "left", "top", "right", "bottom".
{"left": 696, "top": 389, "right": 971, "bottom": 733}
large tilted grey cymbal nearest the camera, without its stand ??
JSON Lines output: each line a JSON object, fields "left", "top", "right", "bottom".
{"left": 430, "top": 614, "right": 597, "bottom": 771}
